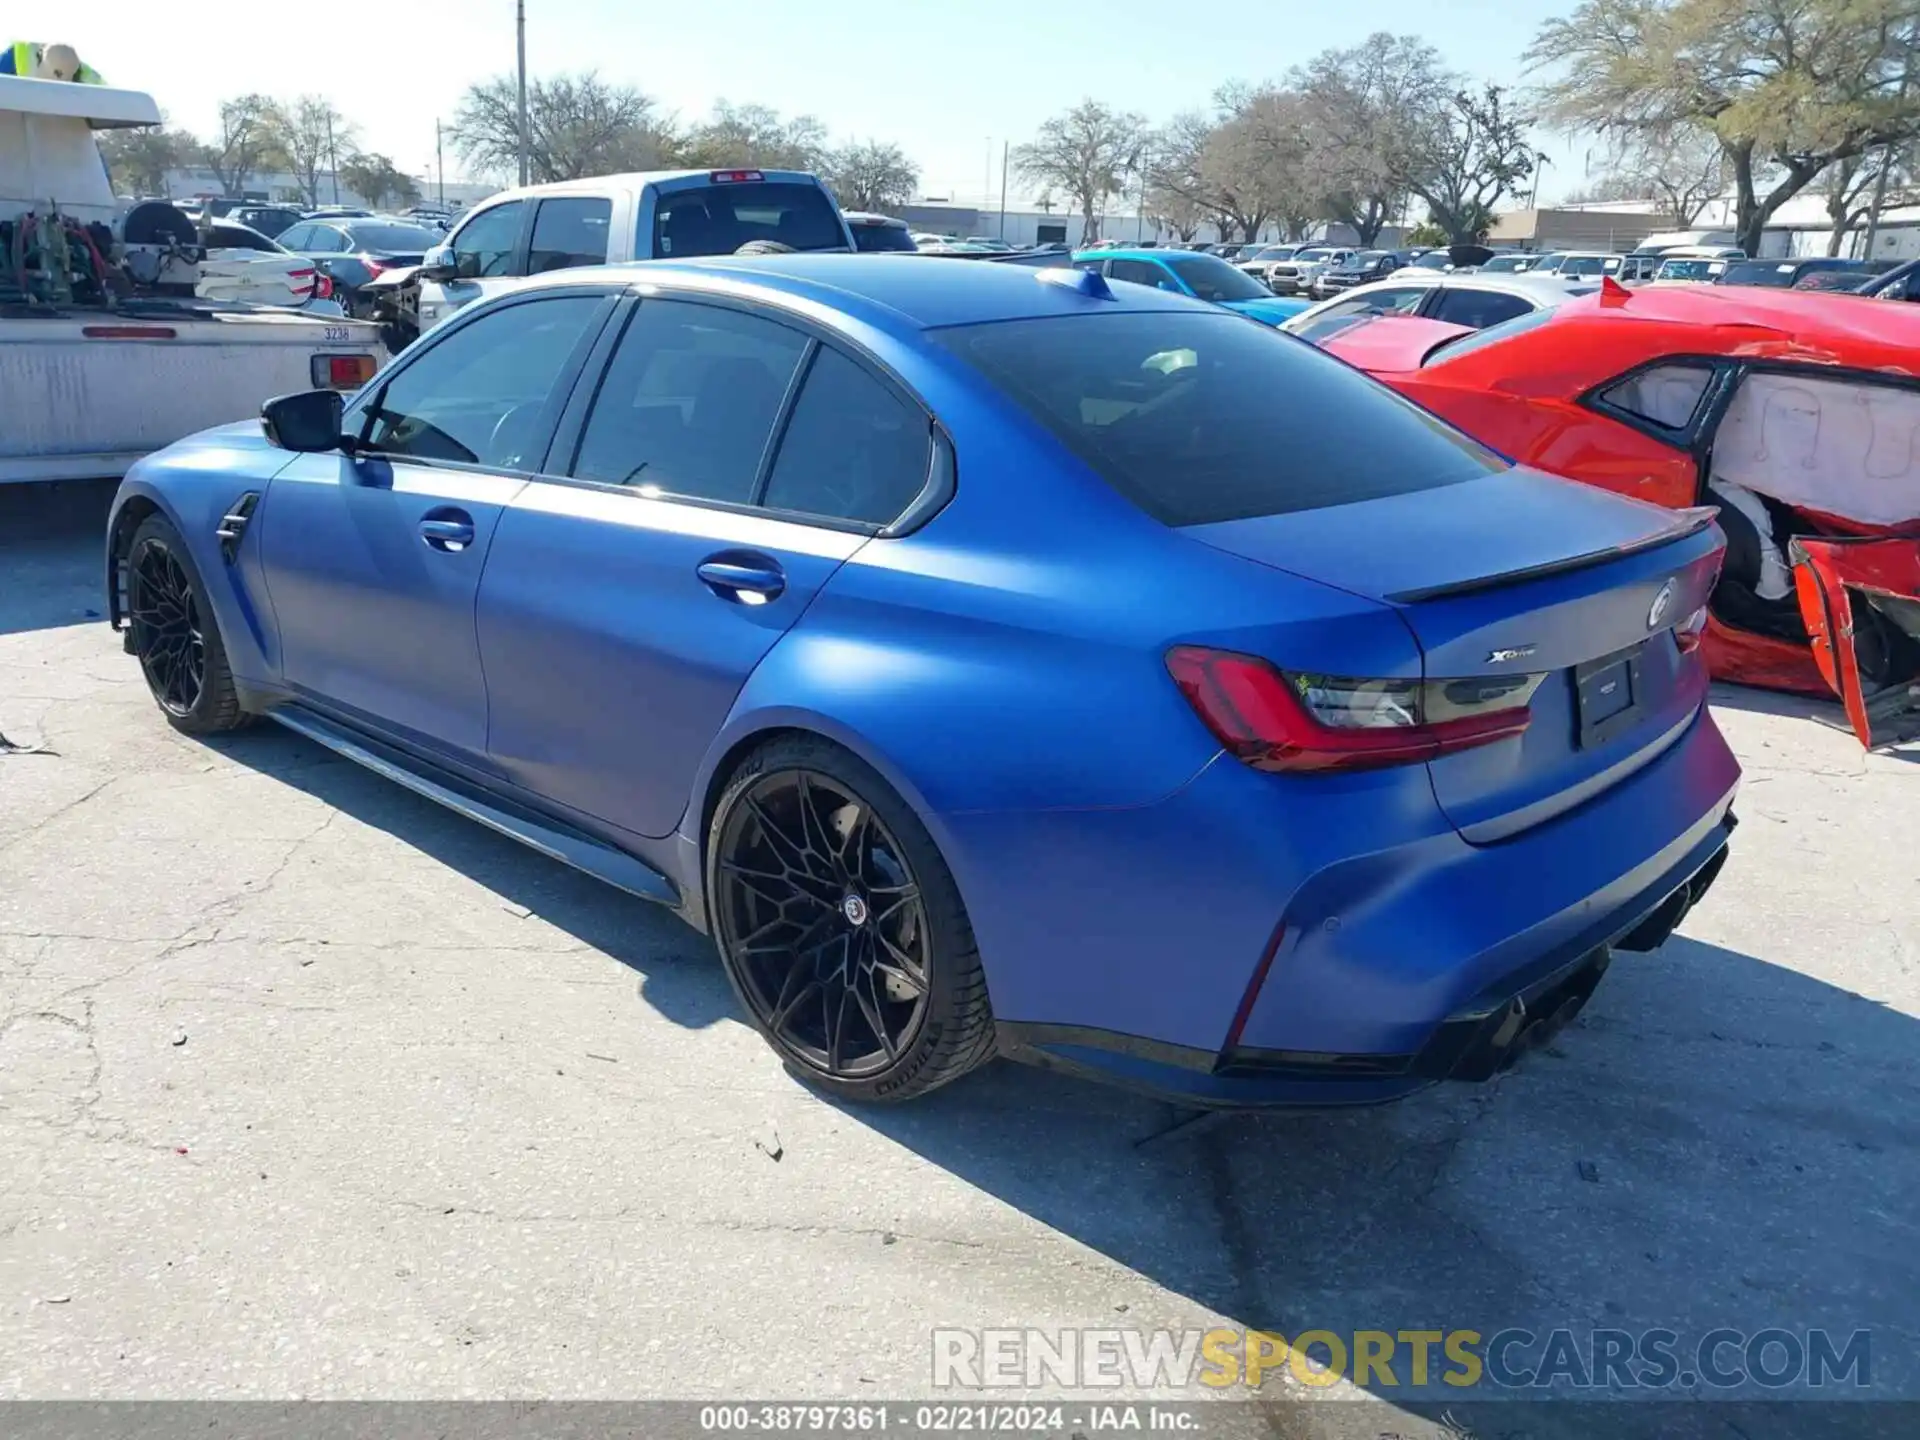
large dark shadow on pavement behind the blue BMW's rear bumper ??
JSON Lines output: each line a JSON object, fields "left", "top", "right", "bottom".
{"left": 847, "top": 937, "right": 1920, "bottom": 1413}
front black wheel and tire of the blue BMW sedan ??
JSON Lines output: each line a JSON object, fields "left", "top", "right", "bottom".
{"left": 127, "top": 515, "right": 252, "bottom": 735}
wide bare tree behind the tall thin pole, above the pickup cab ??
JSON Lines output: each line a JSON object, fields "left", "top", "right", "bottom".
{"left": 449, "top": 71, "right": 676, "bottom": 184}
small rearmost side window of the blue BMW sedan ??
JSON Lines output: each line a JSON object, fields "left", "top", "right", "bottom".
{"left": 762, "top": 346, "right": 933, "bottom": 524}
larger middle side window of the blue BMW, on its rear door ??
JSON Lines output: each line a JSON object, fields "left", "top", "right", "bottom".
{"left": 572, "top": 300, "right": 806, "bottom": 505}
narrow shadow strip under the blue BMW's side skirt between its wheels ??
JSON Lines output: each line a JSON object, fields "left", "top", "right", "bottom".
{"left": 205, "top": 724, "right": 735, "bottom": 1029}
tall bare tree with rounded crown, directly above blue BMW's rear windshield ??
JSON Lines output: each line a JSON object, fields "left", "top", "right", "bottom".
{"left": 1294, "top": 33, "right": 1448, "bottom": 246}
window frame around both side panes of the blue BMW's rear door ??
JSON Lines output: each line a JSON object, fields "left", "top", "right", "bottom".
{"left": 534, "top": 280, "right": 960, "bottom": 540}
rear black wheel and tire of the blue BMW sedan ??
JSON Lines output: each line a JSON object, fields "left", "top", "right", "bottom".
{"left": 707, "top": 735, "right": 995, "bottom": 1102}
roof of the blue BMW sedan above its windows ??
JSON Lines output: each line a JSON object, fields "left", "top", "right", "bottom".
{"left": 515, "top": 253, "right": 1221, "bottom": 332}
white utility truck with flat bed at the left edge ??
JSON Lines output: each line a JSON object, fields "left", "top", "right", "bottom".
{"left": 0, "top": 75, "right": 384, "bottom": 484}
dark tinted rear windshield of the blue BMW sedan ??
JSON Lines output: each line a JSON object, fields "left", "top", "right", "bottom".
{"left": 931, "top": 311, "right": 1505, "bottom": 526}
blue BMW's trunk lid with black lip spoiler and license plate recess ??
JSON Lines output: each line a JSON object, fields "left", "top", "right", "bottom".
{"left": 1185, "top": 468, "right": 1722, "bottom": 843}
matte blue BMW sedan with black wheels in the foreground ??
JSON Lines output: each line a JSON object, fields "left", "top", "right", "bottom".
{"left": 106, "top": 255, "right": 1740, "bottom": 1106}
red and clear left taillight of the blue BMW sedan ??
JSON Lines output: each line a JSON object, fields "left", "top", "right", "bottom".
{"left": 1167, "top": 645, "right": 1546, "bottom": 772}
